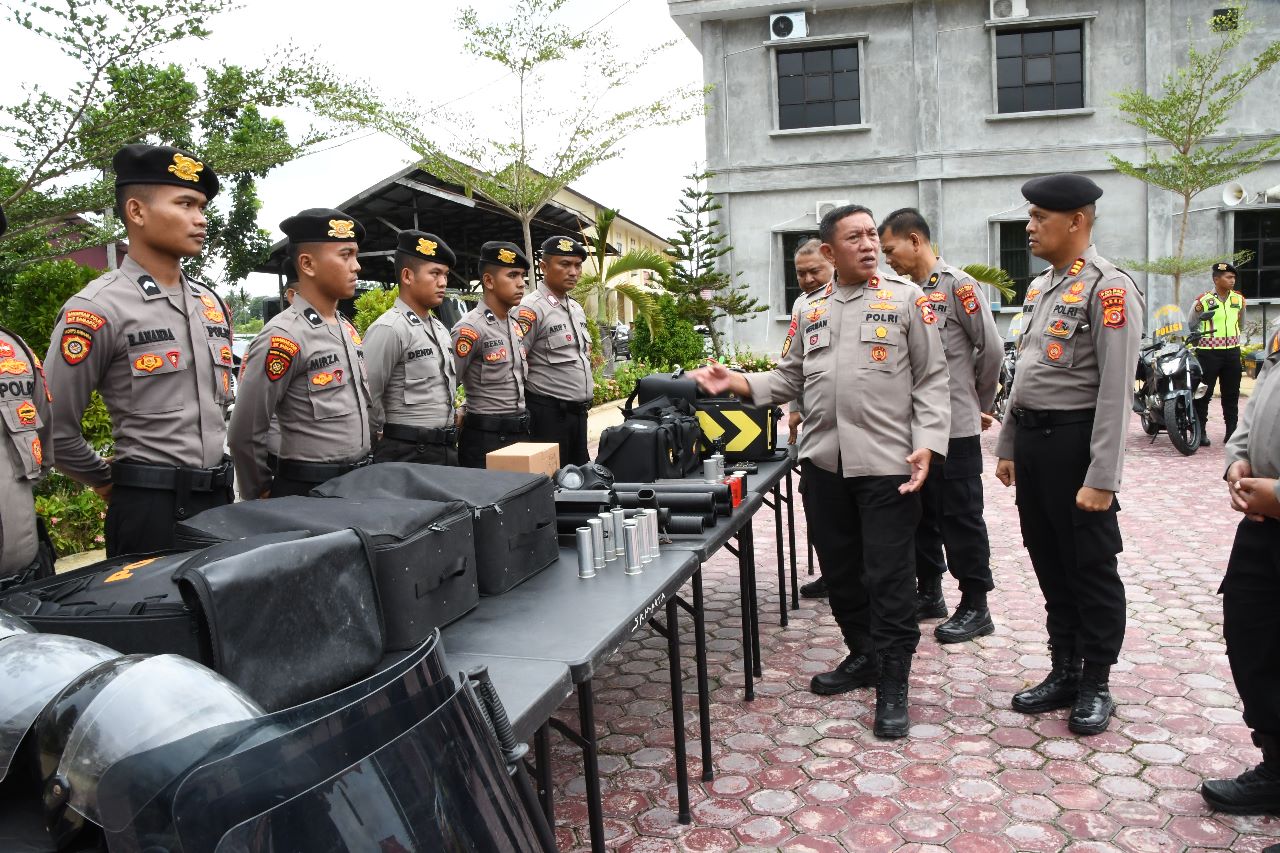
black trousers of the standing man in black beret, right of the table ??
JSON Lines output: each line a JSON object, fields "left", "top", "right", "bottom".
{"left": 1005, "top": 423, "right": 1125, "bottom": 666}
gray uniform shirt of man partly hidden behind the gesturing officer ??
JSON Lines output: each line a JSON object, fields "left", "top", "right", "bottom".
{"left": 920, "top": 259, "right": 1005, "bottom": 438}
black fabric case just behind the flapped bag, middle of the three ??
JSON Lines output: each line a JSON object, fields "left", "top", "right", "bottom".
{"left": 175, "top": 497, "right": 480, "bottom": 652}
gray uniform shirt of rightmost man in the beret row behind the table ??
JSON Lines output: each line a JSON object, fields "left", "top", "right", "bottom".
{"left": 516, "top": 284, "right": 595, "bottom": 402}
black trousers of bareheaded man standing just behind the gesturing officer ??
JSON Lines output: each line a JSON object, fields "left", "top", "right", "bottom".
{"left": 915, "top": 435, "right": 995, "bottom": 590}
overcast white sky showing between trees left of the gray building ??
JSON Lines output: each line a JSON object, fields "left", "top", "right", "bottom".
{"left": 0, "top": 0, "right": 705, "bottom": 292}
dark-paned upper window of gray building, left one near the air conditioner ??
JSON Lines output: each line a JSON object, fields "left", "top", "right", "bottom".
{"left": 777, "top": 42, "right": 863, "bottom": 131}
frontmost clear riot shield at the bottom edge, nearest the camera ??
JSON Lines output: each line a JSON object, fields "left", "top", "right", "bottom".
{"left": 214, "top": 686, "right": 541, "bottom": 853}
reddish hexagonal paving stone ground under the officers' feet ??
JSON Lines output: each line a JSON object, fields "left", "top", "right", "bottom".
{"left": 553, "top": 409, "right": 1280, "bottom": 853}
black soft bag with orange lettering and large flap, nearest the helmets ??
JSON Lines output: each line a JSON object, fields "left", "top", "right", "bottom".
{"left": 0, "top": 529, "right": 384, "bottom": 710}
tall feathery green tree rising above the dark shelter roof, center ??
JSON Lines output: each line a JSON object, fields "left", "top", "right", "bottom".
{"left": 379, "top": 0, "right": 703, "bottom": 257}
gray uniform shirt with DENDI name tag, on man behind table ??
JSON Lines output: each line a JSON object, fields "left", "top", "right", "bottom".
{"left": 364, "top": 298, "right": 458, "bottom": 434}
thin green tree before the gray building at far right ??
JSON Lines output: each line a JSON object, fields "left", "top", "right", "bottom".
{"left": 1108, "top": 3, "right": 1280, "bottom": 305}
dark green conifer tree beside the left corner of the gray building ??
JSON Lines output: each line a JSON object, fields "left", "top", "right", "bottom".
{"left": 666, "top": 170, "right": 768, "bottom": 356}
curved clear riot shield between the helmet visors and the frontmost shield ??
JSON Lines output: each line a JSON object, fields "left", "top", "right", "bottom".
{"left": 99, "top": 631, "right": 453, "bottom": 853}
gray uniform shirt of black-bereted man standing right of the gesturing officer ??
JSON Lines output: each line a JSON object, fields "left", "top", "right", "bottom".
{"left": 996, "top": 245, "right": 1147, "bottom": 492}
